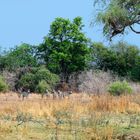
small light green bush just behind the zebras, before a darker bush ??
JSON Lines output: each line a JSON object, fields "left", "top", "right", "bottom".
{"left": 36, "top": 80, "right": 51, "bottom": 94}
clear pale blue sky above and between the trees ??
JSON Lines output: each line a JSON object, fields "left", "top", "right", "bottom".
{"left": 0, "top": 0, "right": 140, "bottom": 49}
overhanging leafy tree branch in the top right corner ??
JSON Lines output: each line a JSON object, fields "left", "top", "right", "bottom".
{"left": 94, "top": 0, "right": 140, "bottom": 38}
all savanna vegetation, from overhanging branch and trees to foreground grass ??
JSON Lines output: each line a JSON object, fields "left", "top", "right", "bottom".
{"left": 0, "top": 0, "right": 140, "bottom": 140}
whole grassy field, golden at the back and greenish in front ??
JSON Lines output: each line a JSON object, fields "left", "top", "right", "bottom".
{"left": 0, "top": 93, "right": 140, "bottom": 140}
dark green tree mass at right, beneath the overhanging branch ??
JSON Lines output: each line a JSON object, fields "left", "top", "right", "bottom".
{"left": 91, "top": 42, "right": 140, "bottom": 79}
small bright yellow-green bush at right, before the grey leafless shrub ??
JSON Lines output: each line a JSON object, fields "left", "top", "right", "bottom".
{"left": 108, "top": 81, "right": 132, "bottom": 96}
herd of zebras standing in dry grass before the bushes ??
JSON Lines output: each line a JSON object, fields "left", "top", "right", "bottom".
{"left": 17, "top": 89, "right": 73, "bottom": 100}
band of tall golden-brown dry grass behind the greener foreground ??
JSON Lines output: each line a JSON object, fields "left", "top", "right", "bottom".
{"left": 0, "top": 94, "right": 140, "bottom": 117}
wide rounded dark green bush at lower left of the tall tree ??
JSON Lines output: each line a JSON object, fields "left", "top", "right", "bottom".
{"left": 18, "top": 67, "right": 59, "bottom": 92}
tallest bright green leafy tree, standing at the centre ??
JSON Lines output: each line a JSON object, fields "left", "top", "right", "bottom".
{"left": 38, "top": 17, "right": 89, "bottom": 81}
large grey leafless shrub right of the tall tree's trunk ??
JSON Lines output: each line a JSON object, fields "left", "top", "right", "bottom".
{"left": 69, "top": 70, "right": 119, "bottom": 94}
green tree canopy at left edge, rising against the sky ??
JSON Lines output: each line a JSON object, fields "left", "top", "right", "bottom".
{"left": 0, "top": 44, "right": 37, "bottom": 71}
